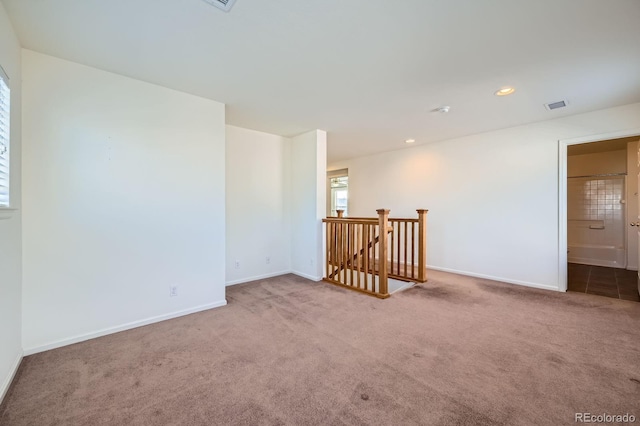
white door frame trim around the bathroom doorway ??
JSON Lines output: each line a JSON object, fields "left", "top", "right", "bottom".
{"left": 558, "top": 128, "right": 640, "bottom": 291}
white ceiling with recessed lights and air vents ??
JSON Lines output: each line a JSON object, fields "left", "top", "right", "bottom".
{"left": 3, "top": 0, "right": 640, "bottom": 161}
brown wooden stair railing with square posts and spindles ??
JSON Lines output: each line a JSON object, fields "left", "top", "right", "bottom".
{"left": 323, "top": 209, "right": 427, "bottom": 298}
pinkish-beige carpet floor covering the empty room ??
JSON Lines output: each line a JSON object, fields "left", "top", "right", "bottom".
{"left": 0, "top": 272, "right": 640, "bottom": 425}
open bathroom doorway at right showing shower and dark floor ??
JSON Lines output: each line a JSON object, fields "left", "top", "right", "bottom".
{"left": 566, "top": 136, "right": 640, "bottom": 301}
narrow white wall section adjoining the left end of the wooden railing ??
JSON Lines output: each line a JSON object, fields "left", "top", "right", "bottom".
{"left": 291, "top": 130, "right": 327, "bottom": 281}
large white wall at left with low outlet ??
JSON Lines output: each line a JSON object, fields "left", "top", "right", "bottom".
{"left": 22, "top": 50, "right": 226, "bottom": 353}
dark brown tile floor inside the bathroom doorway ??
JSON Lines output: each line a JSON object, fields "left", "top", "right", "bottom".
{"left": 568, "top": 263, "right": 640, "bottom": 302}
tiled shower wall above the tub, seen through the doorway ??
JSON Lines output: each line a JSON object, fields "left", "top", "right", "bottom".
{"left": 567, "top": 176, "right": 625, "bottom": 248}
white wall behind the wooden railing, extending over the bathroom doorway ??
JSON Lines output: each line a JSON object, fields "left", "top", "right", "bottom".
{"left": 330, "top": 104, "right": 640, "bottom": 289}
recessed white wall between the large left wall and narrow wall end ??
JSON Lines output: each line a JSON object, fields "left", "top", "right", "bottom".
{"left": 226, "top": 126, "right": 291, "bottom": 285}
